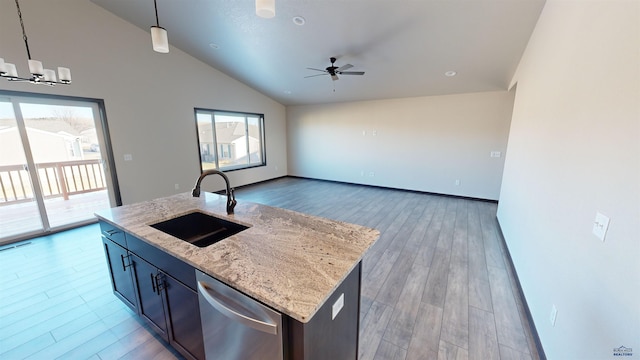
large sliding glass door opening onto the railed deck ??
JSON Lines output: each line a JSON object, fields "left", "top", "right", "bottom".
{"left": 0, "top": 93, "right": 120, "bottom": 244}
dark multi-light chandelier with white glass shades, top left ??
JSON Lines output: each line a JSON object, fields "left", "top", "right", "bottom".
{"left": 0, "top": 0, "right": 71, "bottom": 86}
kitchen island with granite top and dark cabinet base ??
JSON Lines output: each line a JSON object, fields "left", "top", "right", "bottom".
{"left": 96, "top": 193, "right": 379, "bottom": 359}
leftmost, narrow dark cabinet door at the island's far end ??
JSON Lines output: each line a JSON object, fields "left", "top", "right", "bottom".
{"left": 102, "top": 237, "right": 138, "bottom": 313}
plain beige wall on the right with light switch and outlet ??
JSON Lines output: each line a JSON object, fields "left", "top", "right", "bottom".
{"left": 498, "top": 0, "right": 640, "bottom": 359}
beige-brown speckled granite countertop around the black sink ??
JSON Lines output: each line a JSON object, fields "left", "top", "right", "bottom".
{"left": 95, "top": 192, "right": 380, "bottom": 323}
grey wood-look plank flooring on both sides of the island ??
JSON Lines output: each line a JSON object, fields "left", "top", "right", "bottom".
{"left": 0, "top": 178, "right": 540, "bottom": 360}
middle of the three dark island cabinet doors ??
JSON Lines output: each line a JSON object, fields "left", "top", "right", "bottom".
{"left": 131, "top": 254, "right": 169, "bottom": 341}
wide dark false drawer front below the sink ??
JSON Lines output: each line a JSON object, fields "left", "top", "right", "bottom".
{"left": 127, "top": 234, "right": 197, "bottom": 291}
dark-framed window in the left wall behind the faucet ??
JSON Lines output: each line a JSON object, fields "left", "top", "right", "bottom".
{"left": 196, "top": 109, "right": 266, "bottom": 171}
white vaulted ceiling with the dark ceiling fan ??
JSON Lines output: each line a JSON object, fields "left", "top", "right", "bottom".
{"left": 91, "top": 0, "right": 544, "bottom": 105}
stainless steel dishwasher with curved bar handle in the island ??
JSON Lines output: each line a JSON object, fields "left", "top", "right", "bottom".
{"left": 196, "top": 270, "right": 284, "bottom": 360}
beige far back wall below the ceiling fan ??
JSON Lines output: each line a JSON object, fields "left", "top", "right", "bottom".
{"left": 287, "top": 91, "right": 513, "bottom": 200}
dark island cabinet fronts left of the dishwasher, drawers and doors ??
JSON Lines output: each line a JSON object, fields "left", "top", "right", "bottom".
{"left": 100, "top": 222, "right": 205, "bottom": 359}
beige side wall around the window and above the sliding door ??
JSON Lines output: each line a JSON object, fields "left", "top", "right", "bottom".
{"left": 0, "top": 0, "right": 287, "bottom": 203}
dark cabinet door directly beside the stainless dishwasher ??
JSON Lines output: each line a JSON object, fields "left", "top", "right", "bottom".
{"left": 163, "top": 274, "right": 204, "bottom": 359}
